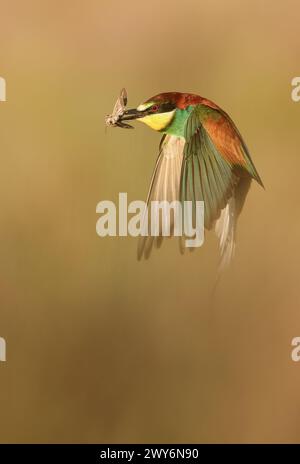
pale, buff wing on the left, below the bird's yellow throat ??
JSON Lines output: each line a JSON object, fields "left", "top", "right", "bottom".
{"left": 138, "top": 135, "right": 185, "bottom": 259}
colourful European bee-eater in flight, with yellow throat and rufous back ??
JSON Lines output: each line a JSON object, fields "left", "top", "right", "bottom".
{"left": 120, "top": 92, "right": 263, "bottom": 268}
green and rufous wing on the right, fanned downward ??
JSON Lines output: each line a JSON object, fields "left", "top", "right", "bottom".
{"left": 180, "top": 104, "right": 262, "bottom": 229}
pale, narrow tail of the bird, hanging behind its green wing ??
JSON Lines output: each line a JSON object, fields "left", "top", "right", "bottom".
{"left": 215, "top": 176, "right": 251, "bottom": 273}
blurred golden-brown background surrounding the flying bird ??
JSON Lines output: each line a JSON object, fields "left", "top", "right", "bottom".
{"left": 0, "top": 0, "right": 300, "bottom": 443}
